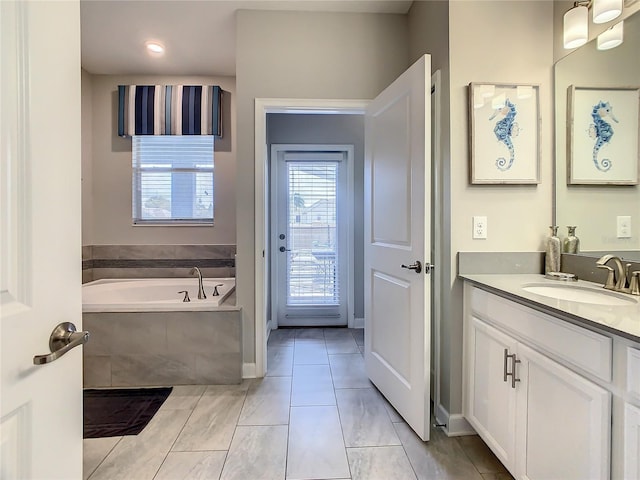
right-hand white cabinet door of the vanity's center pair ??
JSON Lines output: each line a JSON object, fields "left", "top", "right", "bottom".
{"left": 516, "top": 344, "right": 611, "bottom": 480}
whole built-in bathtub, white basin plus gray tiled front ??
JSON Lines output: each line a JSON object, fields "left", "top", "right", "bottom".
{"left": 82, "top": 277, "right": 242, "bottom": 388}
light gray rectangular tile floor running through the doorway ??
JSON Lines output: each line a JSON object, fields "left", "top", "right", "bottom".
{"left": 84, "top": 329, "right": 512, "bottom": 480}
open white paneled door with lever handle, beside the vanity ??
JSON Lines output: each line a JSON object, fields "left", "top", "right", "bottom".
{"left": 364, "top": 55, "right": 431, "bottom": 440}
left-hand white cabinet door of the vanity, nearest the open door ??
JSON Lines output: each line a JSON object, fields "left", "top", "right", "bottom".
{"left": 465, "top": 317, "right": 516, "bottom": 468}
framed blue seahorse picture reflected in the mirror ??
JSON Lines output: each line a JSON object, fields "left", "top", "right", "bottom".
{"left": 567, "top": 85, "right": 640, "bottom": 185}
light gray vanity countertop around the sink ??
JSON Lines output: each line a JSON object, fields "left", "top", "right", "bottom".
{"left": 460, "top": 274, "right": 640, "bottom": 342}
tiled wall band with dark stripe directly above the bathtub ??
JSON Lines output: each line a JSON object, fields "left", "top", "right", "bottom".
{"left": 82, "top": 245, "right": 236, "bottom": 283}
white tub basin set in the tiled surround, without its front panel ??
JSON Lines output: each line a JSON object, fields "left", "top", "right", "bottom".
{"left": 82, "top": 277, "right": 236, "bottom": 312}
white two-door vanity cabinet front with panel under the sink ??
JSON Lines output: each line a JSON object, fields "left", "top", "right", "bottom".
{"left": 464, "top": 285, "right": 611, "bottom": 480}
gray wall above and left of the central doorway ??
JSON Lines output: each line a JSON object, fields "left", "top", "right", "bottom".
{"left": 236, "top": 10, "right": 409, "bottom": 362}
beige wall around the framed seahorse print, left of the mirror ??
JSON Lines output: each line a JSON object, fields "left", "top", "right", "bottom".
{"left": 446, "top": 0, "right": 554, "bottom": 413}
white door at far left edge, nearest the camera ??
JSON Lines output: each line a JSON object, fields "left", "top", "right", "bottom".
{"left": 0, "top": 0, "right": 82, "bottom": 479}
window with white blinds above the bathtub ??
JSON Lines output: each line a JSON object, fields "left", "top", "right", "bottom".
{"left": 132, "top": 135, "right": 214, "bottom": 225}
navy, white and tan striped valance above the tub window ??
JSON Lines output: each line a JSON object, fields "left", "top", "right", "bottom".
{"left": 118, "top": 85, "right": 222, "bottom": 137}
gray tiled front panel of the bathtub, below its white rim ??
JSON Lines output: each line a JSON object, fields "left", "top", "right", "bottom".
{"left": 82, "top": 309, "right": 242, "bottom": 388}
